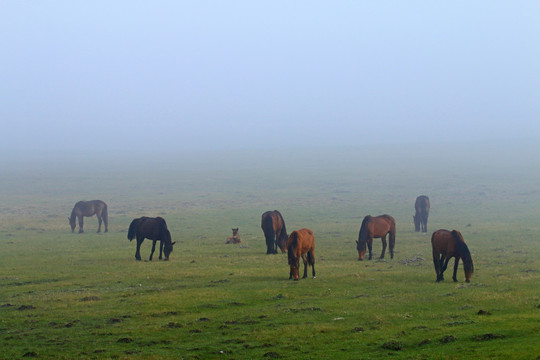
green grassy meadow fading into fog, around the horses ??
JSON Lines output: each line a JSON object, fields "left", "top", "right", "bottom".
{"left": 0, "top": 144, "right": 540, "bottom": 359}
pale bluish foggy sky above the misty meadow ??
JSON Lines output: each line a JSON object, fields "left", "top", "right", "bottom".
{"left": 0, "top": 0, "right": 540, "bottom": 156}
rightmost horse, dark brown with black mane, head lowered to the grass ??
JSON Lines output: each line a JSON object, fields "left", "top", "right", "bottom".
{"left": 431, "top": 229, "right": 474, "bottom": 282}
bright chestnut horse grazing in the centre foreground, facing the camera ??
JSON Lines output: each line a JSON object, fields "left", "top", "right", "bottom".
{"left": 287, "top": 229, "right": 315, "bottom": 281}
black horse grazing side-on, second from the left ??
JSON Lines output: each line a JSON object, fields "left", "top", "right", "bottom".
{"left": 127, "top": 216, "right": 176, "bottom": 261}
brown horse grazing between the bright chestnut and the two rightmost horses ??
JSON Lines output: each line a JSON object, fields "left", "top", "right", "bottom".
{"left": 356, "top": 215, "right": 396, "bottom": 260}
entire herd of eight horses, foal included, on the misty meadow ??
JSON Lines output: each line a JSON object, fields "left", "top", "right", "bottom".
{"left": 68, "top": 195, "right": 474, "bottom": 282}
